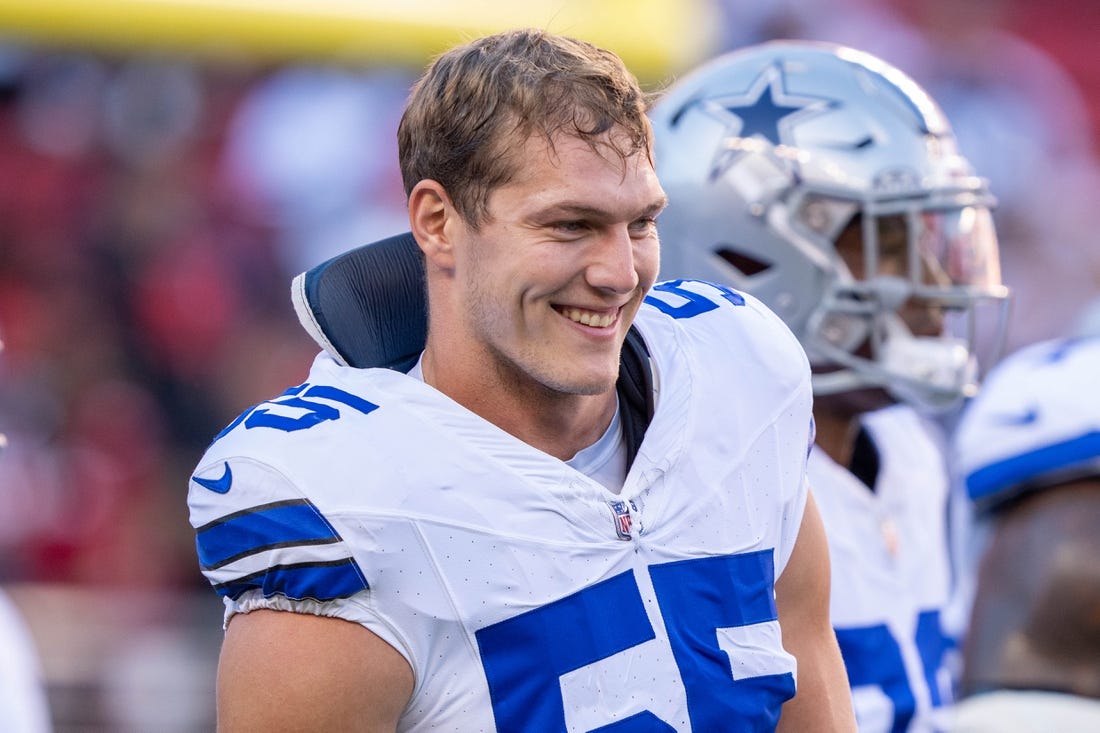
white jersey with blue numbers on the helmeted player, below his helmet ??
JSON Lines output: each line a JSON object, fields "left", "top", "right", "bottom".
{"left": 809, "top": 405, "right": 952, "bottom": 733}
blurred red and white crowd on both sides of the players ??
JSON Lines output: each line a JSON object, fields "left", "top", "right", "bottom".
{"left": 0, "top": 0, "right": 1100, "bottom": 730}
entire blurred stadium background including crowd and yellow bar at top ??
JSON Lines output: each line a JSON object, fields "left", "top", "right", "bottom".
{"left": 0, "top": 0, "right": 1100, "bottom": 733}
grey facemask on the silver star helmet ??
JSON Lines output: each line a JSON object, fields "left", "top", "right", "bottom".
{"left": 798, "top": 188, "right": 1007, "bottom": 411}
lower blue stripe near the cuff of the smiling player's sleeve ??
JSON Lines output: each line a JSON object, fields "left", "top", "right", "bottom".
{"left": 215, "top": 558, "right": 369, "bottom": 601}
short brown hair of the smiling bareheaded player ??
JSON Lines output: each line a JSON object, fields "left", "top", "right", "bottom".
{"left": 397, "top": 29, "right": 652, "bottom": 227}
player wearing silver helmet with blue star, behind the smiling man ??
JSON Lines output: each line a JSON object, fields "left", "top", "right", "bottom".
{"left": 651, "top": 42, "right": 1005, "bottom": 733}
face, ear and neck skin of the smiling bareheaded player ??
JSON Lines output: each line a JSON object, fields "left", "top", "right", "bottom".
{"left": 409, "top": 131, "right": 664, "bottom": 460}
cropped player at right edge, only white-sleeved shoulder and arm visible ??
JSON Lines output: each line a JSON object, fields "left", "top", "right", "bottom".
{"left": 950, "top": 335, "right": 1100, "bottom": 733}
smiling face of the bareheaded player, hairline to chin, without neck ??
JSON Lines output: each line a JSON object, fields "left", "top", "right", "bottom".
{"left": 444, "top": 129, "right": 666, "bottom": 395}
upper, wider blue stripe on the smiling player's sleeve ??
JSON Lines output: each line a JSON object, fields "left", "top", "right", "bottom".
{"left": 195, "top": 500, "right": 340, "bottom": 570}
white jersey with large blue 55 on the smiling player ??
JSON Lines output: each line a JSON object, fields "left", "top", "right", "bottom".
{"left": 189, "top": 281, "right": 812, "bottom": 733}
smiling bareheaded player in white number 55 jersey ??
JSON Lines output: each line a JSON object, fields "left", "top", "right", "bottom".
{"left": 189, "top": 31, "right": 855, "bottom": 733}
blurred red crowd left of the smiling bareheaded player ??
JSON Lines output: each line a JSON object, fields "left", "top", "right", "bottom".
{"left": 0, "top": 48, "right": 415, "bottom": 587}
